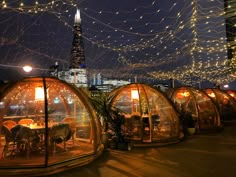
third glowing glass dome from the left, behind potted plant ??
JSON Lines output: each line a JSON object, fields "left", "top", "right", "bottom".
{"left": 170, "top": 87, "right": 220, "bottom": 131}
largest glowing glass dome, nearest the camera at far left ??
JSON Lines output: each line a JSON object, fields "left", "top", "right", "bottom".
{"left": 0, "top": 77, "right": 103, "bottom": 176}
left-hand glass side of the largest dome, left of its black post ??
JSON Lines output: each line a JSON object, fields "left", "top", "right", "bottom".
{"left": 0, "top": 80, "right": 45, "bottom": 167}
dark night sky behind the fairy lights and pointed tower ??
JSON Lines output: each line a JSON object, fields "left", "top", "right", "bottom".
{"left": 0, "top": 0, "right": 234, "bottom": 86}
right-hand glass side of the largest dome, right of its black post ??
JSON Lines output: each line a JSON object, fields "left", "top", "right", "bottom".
{"left": 47, "top": 82, "right": 94, "bottom": 164}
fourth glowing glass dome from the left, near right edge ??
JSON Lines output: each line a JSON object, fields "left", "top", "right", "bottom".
{"left": 205, "top": 88, "right": 236, "bottom": 122}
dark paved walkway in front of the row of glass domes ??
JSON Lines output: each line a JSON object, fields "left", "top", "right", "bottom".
{"left": 45, "top": 126, "right": 236, "bottom": 177}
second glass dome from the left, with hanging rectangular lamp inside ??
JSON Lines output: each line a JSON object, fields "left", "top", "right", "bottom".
{"left": 110, "top": 84, "right": 180, "bottom": 145}
